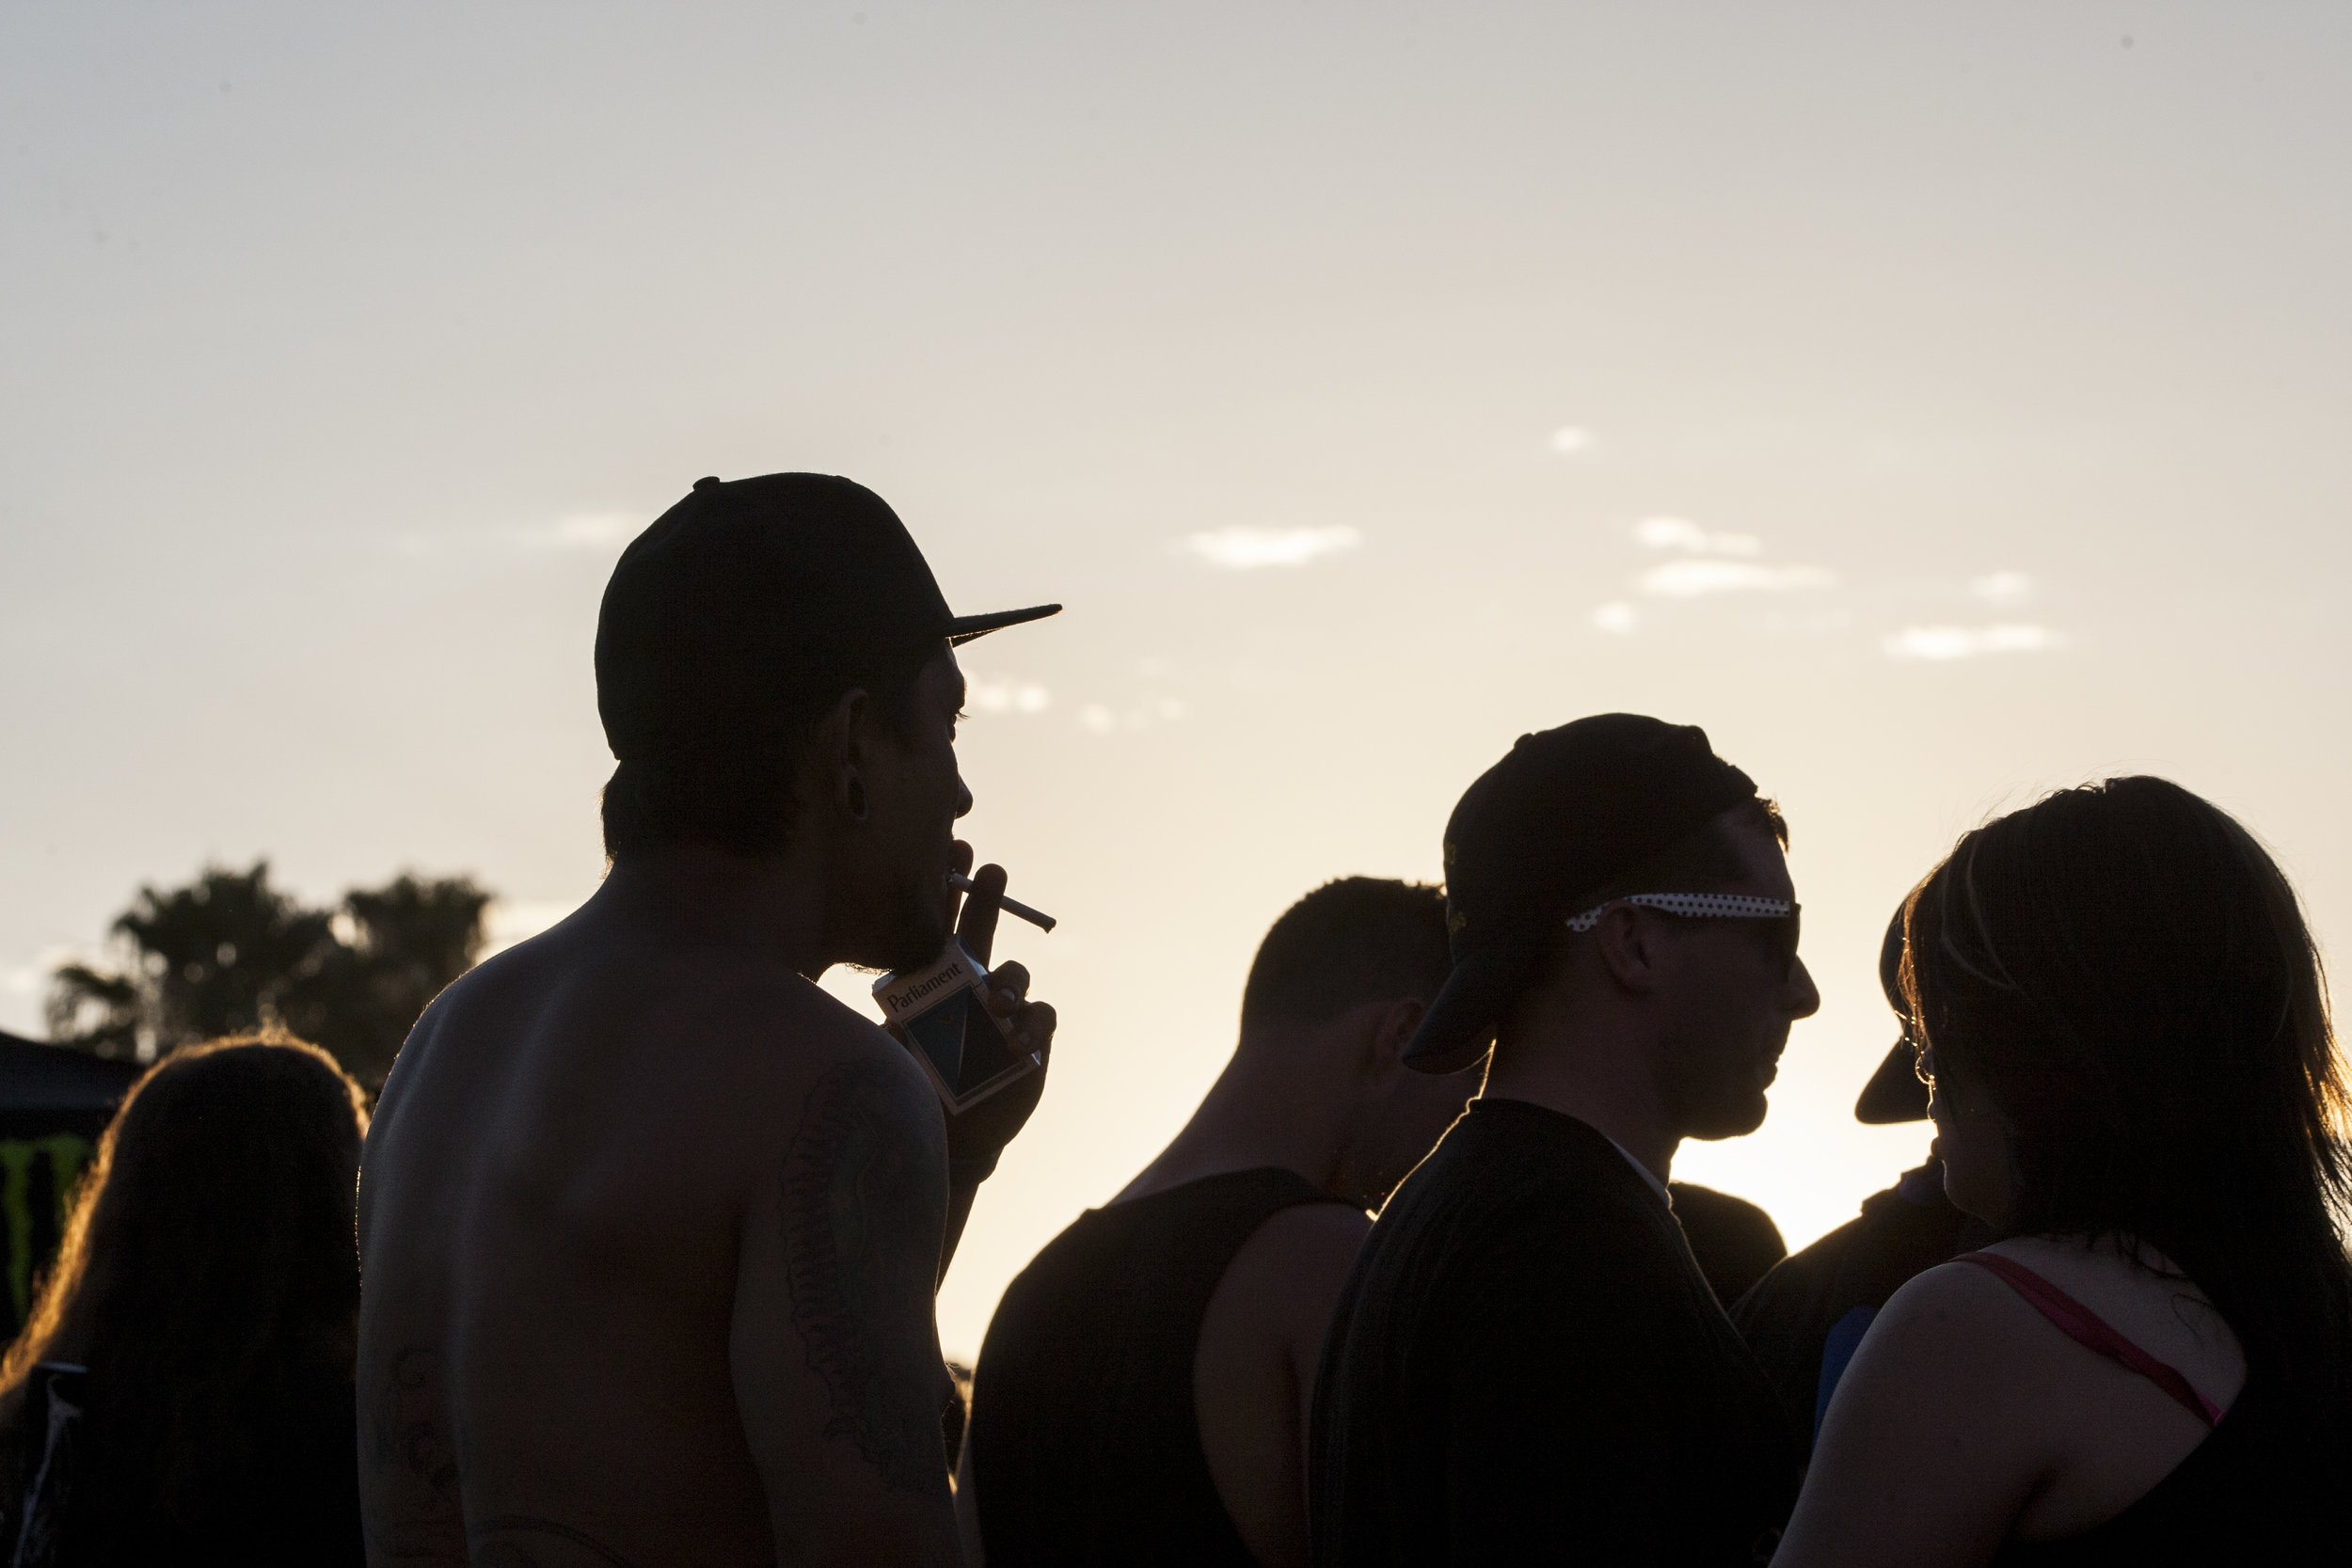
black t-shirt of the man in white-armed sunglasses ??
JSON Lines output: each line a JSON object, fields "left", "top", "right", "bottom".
{"left": 1311, "top": 1101, "right": 1797, "bottom": 1563}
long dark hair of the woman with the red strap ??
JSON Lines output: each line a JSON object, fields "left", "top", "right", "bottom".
{"left": 1905, "top": 778, "right": 2352, "bottom": 1439}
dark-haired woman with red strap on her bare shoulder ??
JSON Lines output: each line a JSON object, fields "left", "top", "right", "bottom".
{"left": 1773, "top": 778, "right": 2352, "bottom": 1568}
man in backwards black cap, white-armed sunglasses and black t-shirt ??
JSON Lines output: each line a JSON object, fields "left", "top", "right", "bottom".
{"left": 1311, "top": 715, "right": 1820, "bottom": 1566}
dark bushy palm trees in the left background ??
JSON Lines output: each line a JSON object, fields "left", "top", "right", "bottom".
{"left": 47, "top": 861, "right": 489, "bottom": 1088}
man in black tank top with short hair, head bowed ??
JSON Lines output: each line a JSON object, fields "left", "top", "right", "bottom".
{"left": 958, "top": 877, "right": 1475, "bottom": 1568}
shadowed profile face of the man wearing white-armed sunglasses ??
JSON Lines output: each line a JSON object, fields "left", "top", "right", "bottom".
{"left": 1661, "top": 818, "right": 1820, "bottom": 1138}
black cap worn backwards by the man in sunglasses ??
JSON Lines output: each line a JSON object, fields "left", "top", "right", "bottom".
{"left": 1405, "top": 712, "right": 1757, "bottom": 1072}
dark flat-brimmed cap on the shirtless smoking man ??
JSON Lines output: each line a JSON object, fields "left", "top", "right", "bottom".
{"left": 596, "top": 472, "right": 1061, "bottom": 762}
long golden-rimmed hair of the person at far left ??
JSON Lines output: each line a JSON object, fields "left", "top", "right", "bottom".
{"left": 0, "top": 1035, "right": 367, "bottom": 1543}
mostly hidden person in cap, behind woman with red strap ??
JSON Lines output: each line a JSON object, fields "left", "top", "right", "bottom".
{"left": 1731, "top": 905, "right": 1994, "bottom": 1453}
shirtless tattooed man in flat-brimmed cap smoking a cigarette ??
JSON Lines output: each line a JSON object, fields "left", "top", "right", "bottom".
{"left": 358, "top": 475, "right": 1057, "bottom": 1568}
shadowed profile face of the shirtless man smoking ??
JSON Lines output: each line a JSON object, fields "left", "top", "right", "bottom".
{"left": 854, "top": 646, "right": 972, "bottom": 969}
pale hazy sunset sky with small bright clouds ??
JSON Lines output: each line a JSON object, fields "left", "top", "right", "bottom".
{"left": 0, "top": 0, "right": 2352, "bottom": 1356}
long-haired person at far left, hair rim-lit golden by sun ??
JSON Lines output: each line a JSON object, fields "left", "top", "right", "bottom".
{"left": 0, "top": 1037, "right": 367, "bottom": 1568}
